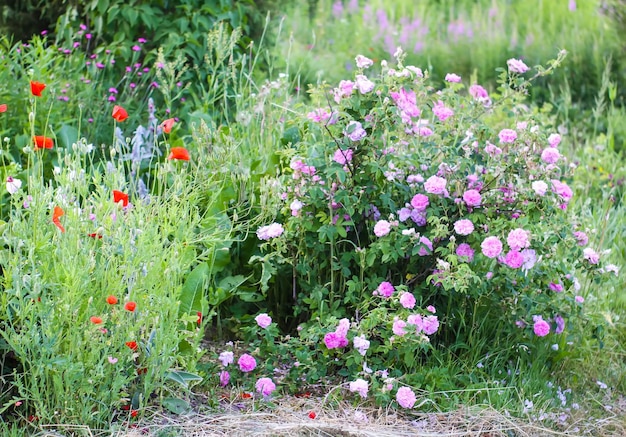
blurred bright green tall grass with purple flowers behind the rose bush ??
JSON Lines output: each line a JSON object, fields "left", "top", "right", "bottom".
{"left": 286, "top": 0, "right": 621, "bottom": 102}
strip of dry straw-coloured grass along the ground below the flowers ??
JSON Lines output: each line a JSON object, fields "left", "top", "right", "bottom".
{"left": 31, "top": 397, "right": 626, "bottom": 437}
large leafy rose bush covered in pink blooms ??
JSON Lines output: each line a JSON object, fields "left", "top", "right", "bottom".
{"left": 247, "top": 50, "right": 616, "bottom": 405}
